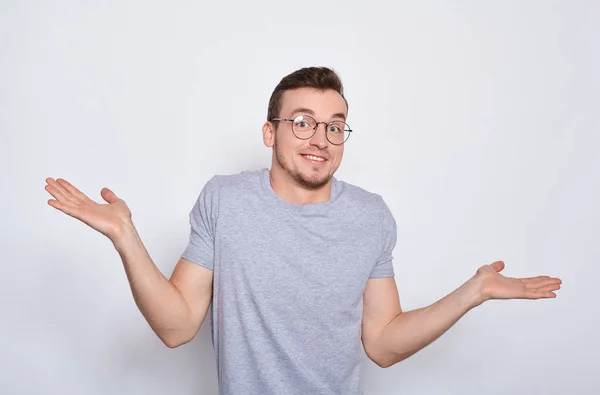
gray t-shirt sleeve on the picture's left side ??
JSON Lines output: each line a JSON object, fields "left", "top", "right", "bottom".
{"left": 181, "top": 177, "right": 219, "bottom": 270}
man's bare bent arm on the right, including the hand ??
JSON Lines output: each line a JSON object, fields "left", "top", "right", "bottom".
{"left": 362, "top": 261, "right": 561, "bottom": 367}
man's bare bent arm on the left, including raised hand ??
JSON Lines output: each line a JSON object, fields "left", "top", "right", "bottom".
{"left": 45, "top": 178, "right": 213, "bottom": 348}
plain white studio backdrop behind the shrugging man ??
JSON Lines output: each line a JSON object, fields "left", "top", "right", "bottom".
{"left": 0, "top": 1, "right": 600, "bottom": 395}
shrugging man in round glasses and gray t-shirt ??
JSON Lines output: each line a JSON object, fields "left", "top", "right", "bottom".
{"left": 46, "top": 67, "right": 560, "bottom": 395}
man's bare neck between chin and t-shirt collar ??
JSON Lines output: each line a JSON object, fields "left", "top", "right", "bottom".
{"left": 269, "top": 166, "right": 332, "bottom": 204}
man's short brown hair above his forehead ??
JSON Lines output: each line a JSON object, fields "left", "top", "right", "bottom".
{"left": 267, "top": 67, "right": 348, "bottom": 121}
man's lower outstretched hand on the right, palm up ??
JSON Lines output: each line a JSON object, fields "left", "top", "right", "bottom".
{"left": 474, "top": 261, "right": 562, "bottom": 300}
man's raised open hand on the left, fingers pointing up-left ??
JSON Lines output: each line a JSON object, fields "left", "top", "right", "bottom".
{"left": 45, "top": 178, "right": 131, "bottom": 239}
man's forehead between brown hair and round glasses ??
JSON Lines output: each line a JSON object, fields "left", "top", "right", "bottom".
{"left": 281, "top": 88, "right": 347, "bottom": 118}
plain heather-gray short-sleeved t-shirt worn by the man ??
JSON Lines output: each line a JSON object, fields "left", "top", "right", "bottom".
{"left": 182, "top": 169, "right": 396, "bottom": 395}
